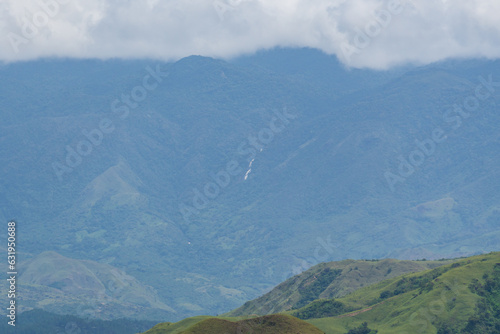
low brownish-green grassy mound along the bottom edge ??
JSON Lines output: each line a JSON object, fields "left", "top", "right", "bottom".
{"left": 144, "top": 315, "right": 323, "bottom": 334}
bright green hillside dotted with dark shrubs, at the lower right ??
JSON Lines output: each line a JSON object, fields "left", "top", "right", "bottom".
{"left": 290, "top": 253, "right": 500, "bottom": 334}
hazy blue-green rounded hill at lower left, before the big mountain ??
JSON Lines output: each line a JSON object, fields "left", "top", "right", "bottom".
{"left": 6, "top": 252, "right": 175, "bottom": 320}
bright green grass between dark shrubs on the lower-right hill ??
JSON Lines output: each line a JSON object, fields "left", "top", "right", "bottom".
{"left": 307, "top": 253, "right": 500, "bottom": 334}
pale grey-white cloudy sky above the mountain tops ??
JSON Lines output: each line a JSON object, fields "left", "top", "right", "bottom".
{"left": 0, "top": 0, "right": 500, "bottom": 68}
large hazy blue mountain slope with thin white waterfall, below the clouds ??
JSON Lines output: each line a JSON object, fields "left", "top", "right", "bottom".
{"left": 0, "top": 50, "right": 500, "bottom": 321}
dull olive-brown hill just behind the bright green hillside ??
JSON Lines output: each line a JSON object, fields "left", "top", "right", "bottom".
{"left": 226, "top": 259, "right": 450, "bottom": 316}
